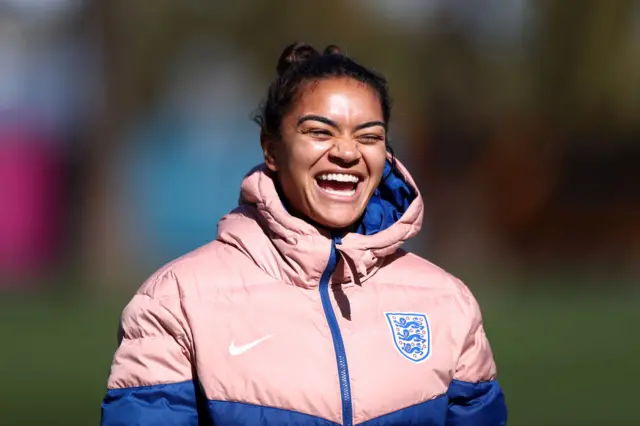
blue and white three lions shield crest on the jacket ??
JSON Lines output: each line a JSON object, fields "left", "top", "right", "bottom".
{"left": 385, "top": 312, "right": 431, "bottom": 363}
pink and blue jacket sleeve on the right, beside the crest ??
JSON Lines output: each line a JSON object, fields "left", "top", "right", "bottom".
{"left": 446, "top": 287, "right": 507, "bottom": 426}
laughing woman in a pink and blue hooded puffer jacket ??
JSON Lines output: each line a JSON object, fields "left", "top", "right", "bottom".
{"left": 102, "top": 44, "right": 506, "bottom": 426}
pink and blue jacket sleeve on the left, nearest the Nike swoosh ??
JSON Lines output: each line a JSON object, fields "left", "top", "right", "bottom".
{"left": 101, "top": 276, "right": 198, "bottom": 426}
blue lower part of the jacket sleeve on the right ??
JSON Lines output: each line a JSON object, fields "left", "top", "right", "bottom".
{"left": 447, "top": 380, "right": 507, "bottom": 426}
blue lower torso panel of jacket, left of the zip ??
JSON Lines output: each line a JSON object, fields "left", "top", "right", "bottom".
{"left": 209, "top": 401, "right": 338, "bottom": 426}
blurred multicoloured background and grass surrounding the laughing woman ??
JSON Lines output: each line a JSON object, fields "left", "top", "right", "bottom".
{"left": 0, "top": 0, "right": 640, "bottom": 426}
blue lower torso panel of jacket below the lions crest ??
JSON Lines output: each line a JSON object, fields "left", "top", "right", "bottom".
{"left": 358, "top": 395, "right": 448, "bottom": 426}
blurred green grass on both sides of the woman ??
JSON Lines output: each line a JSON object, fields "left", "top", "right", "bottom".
{"left": 0, "top": 288, "right": 640, "bottom": 426}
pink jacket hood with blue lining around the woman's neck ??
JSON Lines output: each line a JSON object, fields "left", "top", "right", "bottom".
{"left": 218, "top": 160, "right": 424, "bottom": 288}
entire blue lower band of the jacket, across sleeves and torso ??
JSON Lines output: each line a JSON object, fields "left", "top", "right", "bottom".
{"left": 101, "top": 380, "right": 507, "bottom": 426}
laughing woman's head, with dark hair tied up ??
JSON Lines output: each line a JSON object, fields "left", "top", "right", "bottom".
{"left": 257, "top": 44, "right": 390, "bottom": 229}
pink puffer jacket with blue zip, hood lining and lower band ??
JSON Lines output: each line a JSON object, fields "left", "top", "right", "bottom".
{"left": 102, "top": 158, "right": 506, "bottom": 426}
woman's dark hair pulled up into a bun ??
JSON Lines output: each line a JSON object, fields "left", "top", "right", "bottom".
{"left": 254, "top": 43, "right": 391, "bottom": 144}
